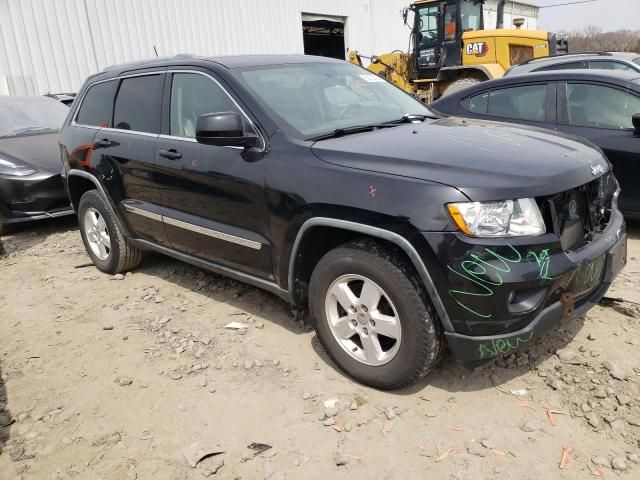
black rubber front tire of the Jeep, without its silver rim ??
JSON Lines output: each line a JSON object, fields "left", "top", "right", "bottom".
{"left": 309, "top": 239, "right": 444, "bottom": 390}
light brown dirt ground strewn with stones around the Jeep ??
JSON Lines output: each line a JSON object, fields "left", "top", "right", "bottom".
{"left": 0, "top": 218, "right": 640, "bottom": 480}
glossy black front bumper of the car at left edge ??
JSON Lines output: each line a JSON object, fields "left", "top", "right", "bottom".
{"left": 0, "top": 171, "right": 74, "bottom": 224}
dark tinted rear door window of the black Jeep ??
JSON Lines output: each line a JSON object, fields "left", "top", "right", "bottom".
{"left": 113, "top": 75, "right": 163, "bottom": 133}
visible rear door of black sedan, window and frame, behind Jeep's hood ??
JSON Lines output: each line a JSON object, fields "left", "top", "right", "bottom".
{"left": 458, "top": 82, "right": 556, "bottom": 129}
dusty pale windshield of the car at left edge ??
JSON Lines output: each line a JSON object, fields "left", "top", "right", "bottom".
{"left": 0, "top": 97, "right": 69, "bottom": 137}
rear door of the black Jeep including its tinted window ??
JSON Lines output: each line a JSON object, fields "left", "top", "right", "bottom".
{"left": 92, "top": 69, "right": 167, "bottom": 245}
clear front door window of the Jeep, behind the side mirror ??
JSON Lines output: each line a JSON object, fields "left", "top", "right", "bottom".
{"left": 170, "top": 73, "right": 240, "bottom": 138}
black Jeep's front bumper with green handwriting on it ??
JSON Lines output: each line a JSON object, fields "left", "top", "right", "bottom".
{"left": 428, "top": 209, "right": 626, "bottom": 362}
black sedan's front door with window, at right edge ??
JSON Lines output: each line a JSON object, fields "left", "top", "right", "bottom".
{"left": 558, "top": 81, "right": 640, "bottom": 212}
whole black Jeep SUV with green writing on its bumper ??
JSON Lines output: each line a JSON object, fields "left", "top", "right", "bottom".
{"left": 60, "top": 56, "right": 626, "bottom": 388}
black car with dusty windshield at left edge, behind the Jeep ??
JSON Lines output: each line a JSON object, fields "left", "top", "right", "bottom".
{"left": 0, "top": 96, "right": 73, "bottom": 232}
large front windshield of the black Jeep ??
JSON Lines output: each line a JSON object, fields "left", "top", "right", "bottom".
{"left": 240, "top": 63, "right": 433, "bottom": 138}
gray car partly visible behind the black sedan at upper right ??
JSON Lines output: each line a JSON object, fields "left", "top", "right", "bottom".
{"left": 505, "top": 52, "right": 640, "bottom": 76}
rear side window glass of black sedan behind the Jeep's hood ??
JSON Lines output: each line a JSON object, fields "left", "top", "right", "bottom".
{"left": 465, "top": 85, "right": 547, "bottom": 122}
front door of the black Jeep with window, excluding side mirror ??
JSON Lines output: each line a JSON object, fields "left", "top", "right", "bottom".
{"left": 156, "top": 70, "right": 273, "bottom": 278}
